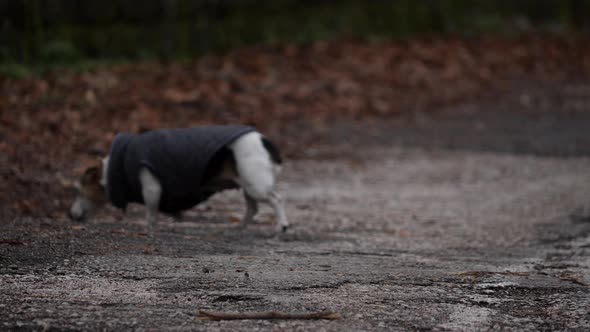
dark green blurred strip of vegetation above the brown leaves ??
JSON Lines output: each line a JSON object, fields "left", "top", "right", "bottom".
{"left": 0, "top": 0, "right": 590, "bottom": 72}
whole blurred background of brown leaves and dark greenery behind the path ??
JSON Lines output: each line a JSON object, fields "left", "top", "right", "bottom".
{"left": 0, "top": 0, "right": 590, "bottom": 216}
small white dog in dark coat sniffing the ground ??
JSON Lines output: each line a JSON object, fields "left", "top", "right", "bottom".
{"left": 70, "top": 125, "right": 289, "bottom": 232}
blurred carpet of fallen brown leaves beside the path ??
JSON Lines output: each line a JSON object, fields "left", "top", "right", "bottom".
{"left": 0, "top": 35, "right": 590, "bottom": 219}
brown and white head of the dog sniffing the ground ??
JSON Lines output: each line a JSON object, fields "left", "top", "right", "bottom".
{"left": 70, "top": 163, "right": 108, "bottom": 221}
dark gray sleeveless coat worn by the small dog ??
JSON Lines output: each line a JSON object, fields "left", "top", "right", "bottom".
{"left": 107, "top": 125, "right": 255, "bottom": 213}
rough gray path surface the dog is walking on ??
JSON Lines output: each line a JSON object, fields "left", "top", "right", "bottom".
{"left": 0, "top": 81, "right": 590, "bottom": 331}
